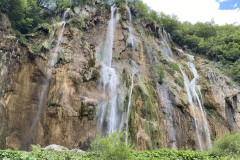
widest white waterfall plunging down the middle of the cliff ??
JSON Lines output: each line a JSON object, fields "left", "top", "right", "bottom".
{"left": 98, "top": 6, "right": 122, "bottom": 134}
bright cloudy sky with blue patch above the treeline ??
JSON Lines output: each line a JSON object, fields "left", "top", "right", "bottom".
{"left": 143, "top": 0, "right": 240, "bottom": 25}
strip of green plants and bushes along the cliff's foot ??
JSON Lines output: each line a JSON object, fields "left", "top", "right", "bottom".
{"left": 0, "top": 133, "right": 240, "bottom": 160}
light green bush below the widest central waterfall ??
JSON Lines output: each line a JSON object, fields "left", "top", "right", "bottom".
{"left": 91, "top": 132, "right": 133, "bottom": 160}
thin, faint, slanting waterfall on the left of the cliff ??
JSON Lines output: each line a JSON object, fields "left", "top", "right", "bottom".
{"left": 25, "top": 8, "right": 70, "bottom": 147}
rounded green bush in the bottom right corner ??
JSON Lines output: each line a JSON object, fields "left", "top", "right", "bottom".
{"left": 211, "top": 132, "right": 240, "bottom": 158}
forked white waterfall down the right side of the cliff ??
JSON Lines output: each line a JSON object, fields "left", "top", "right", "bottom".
{"left": 156, "top": 30, "right": 212, "bottom": 150}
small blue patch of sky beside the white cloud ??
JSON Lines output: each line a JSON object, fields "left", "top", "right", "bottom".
{"left": 218, "top": 0, "right": 240, "bottom": 10}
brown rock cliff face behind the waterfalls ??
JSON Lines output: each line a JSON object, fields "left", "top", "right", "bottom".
{"left": 0, "top": 3, "right": 240, "bottom": 150}
